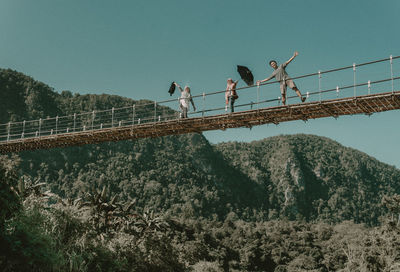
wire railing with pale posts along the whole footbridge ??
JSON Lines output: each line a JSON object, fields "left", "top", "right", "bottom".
{"left": 0, "top": 56, "right": 400, "bottom": 142}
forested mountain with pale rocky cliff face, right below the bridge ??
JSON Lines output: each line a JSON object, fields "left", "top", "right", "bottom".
{"left": 216, "top": 135, "right": 400, "bottom": 224}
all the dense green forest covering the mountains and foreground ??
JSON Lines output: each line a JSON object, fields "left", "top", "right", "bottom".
{"left": 0, "top": 70, "right": 400, "bottom": 271}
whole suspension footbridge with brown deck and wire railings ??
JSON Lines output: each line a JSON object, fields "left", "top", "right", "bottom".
{"left": 0, "top": 56, "right": 400, "bottom": 154}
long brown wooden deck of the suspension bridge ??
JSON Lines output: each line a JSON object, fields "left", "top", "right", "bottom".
{"left": 0, "top": 91, "right": 400, "bottom": 154}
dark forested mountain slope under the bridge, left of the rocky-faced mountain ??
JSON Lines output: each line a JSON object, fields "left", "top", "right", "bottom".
{"left": 20, "top": 134, "right": 267, "bottom": 219}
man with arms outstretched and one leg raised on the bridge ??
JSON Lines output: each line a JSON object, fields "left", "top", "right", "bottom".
{"left": 257, "top": 51, "right": 306, "bottom": 105}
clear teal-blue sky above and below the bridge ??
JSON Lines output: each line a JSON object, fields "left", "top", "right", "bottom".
{"left": 0, "top": 0, "right": 400, "bottom": 168}
